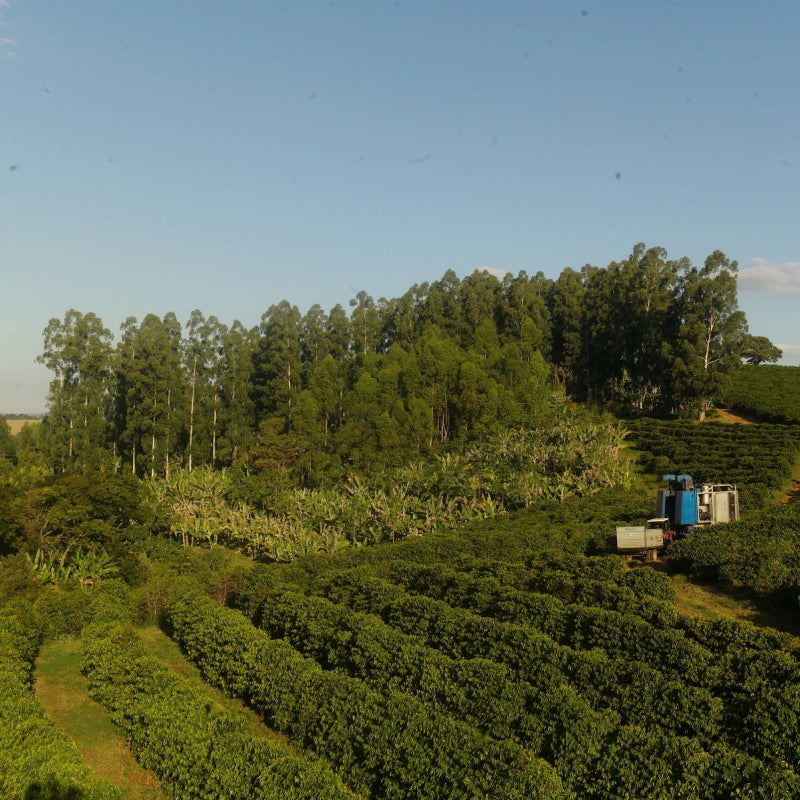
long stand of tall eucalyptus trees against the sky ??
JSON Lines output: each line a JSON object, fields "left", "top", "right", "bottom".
{"left": 17, "top": 244, "right": 780, "bottom": 487}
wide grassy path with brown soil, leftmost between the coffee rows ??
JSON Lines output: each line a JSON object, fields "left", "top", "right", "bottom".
{"left": 34, "top": 638, "right": 168, "bottom": 800}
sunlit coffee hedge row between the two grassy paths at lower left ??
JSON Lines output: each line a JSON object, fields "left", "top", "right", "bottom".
{"left": 83, "top": 592, "right": 353, "bottom": 800}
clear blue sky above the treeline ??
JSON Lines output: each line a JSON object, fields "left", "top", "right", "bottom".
{"left": 0, "top": 0, "right": 800, "bottom": 412}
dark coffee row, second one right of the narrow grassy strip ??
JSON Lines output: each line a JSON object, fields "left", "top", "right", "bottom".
{"left": 255, "top": 591, "right": 752, "bottom": 798}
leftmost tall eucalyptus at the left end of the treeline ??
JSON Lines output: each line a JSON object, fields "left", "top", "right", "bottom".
{"left": 37, "top": 309, "right": 113, "bottom": 472}
